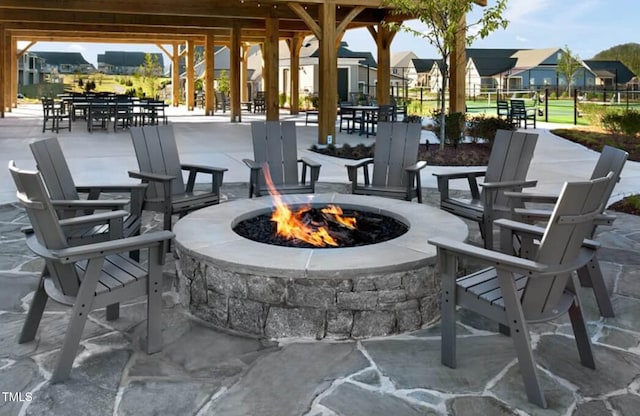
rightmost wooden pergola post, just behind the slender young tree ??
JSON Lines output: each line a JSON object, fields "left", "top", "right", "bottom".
{"left": 449, "top": 16, "right": 467, "bottom": 113}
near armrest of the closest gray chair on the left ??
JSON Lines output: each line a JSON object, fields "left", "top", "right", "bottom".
{"left": 28, "top": 230, "right": 175, "bottom": 263}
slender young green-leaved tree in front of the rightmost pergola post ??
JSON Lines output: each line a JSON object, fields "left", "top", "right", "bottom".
{"left": 385, "top": 0, "right": 509, "bottom": 148}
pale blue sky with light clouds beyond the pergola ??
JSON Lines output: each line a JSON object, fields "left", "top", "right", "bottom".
{"left": 21, "top": 0, "right": 640, "bottom": 65}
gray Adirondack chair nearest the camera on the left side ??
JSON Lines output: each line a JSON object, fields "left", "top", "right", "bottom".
{"left": 9, "top": 161, "right": 173, "bottom": 383}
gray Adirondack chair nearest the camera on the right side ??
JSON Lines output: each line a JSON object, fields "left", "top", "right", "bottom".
{"left": 429, "top": 176, "right": 611, "bottom": 407}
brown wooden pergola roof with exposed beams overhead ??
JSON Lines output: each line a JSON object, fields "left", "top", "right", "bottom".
{"left": 0, "top": 0, "right": 402, "bottom": 43}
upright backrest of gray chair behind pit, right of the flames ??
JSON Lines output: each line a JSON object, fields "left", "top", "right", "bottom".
{"left": 371, "top": 122, "right": 421, "bottom": 187}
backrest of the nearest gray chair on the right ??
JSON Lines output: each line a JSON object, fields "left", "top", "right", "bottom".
{"left": 522, "top": 174, "right": 613, "bottom": 319}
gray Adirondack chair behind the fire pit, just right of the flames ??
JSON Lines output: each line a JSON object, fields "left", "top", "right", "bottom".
{"left": 345, "top": 121, "right": 427, "bottom": 203}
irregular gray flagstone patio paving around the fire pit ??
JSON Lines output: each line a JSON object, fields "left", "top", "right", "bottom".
{"left": 0, "top": 183, "right": 640, "bottom": 416}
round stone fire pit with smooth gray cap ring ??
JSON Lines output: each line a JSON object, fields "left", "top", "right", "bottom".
{"left": 174, "top": 194, "right": 467, "bottom": 339}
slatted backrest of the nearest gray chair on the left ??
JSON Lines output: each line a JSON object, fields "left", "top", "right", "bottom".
{"left": 9, "top": 161, "right": 79, "bottom": 296}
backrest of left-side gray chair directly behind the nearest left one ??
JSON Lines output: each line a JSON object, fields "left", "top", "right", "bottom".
{"left": 29, "top": 137, "right": 79, "bottom": 200}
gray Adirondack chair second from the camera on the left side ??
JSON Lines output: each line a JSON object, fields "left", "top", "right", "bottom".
{"left": 29, "top": 137, "right": 147, "bottom": 245}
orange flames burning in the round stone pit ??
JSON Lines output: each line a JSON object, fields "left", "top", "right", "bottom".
{"left": 262, "top": 164, "right": 356, "bottom": 247}
